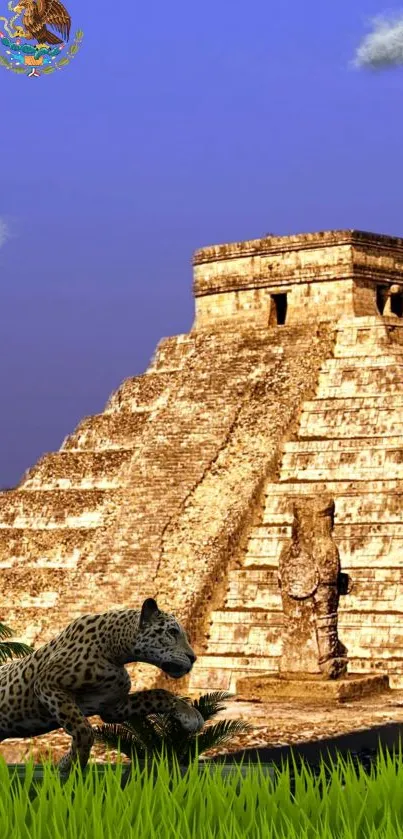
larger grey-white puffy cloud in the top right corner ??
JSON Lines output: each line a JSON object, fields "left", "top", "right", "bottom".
{"left": 353, "top": 12, "right": 403, "bottom": 70}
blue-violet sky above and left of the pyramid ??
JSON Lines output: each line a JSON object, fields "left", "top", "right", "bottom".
{"left": 0, "top": 0, "right": 403, "bottom": 486}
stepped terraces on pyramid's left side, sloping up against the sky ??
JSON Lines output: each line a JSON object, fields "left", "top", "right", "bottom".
{"left": 0, "top": 335, "right": 198, "bottom": 646}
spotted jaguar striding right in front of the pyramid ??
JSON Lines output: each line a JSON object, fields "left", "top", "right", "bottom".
{"left": 0, "top": 598, "right": 204, "bottom": 772}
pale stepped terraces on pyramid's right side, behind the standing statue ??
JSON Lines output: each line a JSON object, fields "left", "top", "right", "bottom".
{"left": 190, "top": 317, "right": 403, "bottom": 693}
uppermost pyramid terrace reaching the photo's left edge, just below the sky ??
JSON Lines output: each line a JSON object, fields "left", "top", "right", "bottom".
{"left": 0, "top": 489, "right": 120, "bottom": 530}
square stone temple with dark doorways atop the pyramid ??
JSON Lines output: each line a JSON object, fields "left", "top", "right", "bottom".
{"left": 193, "top": 230, "right": 403, "bottom": 328}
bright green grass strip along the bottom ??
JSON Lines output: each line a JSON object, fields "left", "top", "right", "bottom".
{"left": 0, "top": 742, "right": 403, "bottom": 839}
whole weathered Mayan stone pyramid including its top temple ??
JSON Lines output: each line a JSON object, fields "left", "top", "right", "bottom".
{"left": 0, "top": 230, "right": 403, "bottom": 695}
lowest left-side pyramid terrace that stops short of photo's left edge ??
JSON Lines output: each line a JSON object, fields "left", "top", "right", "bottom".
{"left": 19, "top": 448, "right": 136, "bottom": 490}
